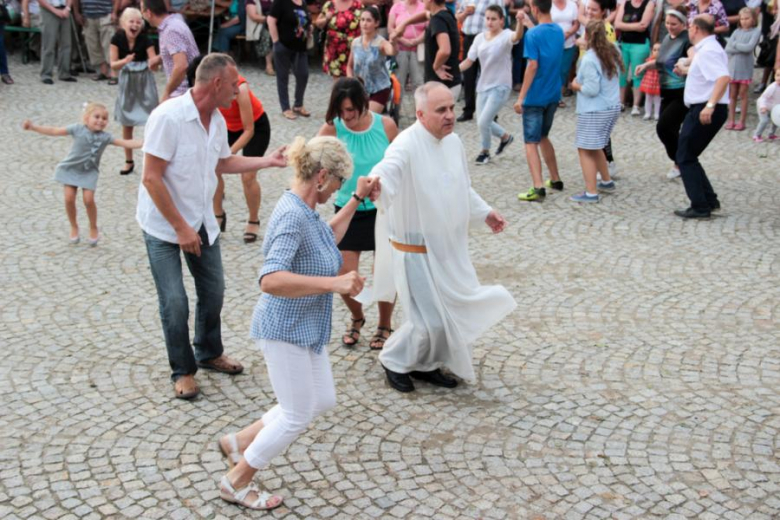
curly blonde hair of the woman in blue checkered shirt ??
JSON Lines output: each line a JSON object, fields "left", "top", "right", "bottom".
{"left": 285, "top": 136, "right": 353, "bottom": 182}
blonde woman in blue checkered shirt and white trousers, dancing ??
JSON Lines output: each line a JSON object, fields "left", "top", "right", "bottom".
{"left": 219, "top": 137, "right": 375, "bottom": 509}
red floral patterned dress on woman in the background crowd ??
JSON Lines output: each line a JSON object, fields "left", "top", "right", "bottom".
{"left": 322, "top": 0, "right": 363, "bottom": 78}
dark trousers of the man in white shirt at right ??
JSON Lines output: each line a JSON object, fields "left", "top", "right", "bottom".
{"left": 677, "top": 103, "right": 728, "bottom": 211}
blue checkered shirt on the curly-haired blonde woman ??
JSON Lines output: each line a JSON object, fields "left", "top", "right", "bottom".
{"left": 250, "top": 191, "right": 342, "bottom": 354}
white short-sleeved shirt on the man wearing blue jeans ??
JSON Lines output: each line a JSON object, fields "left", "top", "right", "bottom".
{"left": 135, "top": 91, "right": 230, "bottom": 245}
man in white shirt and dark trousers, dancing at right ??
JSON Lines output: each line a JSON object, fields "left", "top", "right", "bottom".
{"left": 674, "top": 14, "right": 731, "bottom": 219}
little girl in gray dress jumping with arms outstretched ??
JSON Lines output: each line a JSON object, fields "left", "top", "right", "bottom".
{"left": 22, "top": 103, "right": 143, "bottom": 247}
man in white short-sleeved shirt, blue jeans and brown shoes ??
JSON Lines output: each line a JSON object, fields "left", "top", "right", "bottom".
{"left": 136, "top": 53, "right": 286, "bottom": 399}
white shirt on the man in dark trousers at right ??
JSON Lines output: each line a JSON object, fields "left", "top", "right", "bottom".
{"left": 683, "top": 35, "right": 729, "bottom": 107}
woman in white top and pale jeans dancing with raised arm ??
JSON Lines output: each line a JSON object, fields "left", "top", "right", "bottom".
{"left": 460, "top": 5, "right": 525, "bottom": 164}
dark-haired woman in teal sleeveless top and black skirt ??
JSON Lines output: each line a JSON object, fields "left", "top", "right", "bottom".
{"left": 318, "top": 78, "right": 398, "bottom": 350}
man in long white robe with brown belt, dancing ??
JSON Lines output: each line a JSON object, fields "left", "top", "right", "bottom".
{"left": 370, "top": 82, "right": 517, "bottom": 392}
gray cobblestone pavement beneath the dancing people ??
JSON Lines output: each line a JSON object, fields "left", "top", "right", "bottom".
{"left": 0, "top": 55, "right": 780, "bottom": 520}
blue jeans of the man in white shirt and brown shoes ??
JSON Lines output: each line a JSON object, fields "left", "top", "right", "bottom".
{"left": 144, "top": 227, "right": 225, "bottom": 381}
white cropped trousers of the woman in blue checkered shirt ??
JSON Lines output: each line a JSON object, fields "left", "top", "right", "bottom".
{"left": 244, "top": 339, "right": 336, "bottom": 469}
